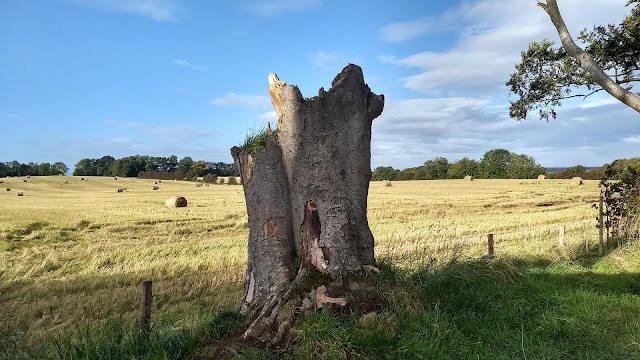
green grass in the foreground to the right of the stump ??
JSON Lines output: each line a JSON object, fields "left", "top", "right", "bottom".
{"left": 235, "top": 245, "right": 640, "bottom": 359}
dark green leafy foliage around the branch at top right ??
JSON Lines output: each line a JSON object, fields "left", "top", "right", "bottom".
{"left": 506, "top": 0, "right": 640, "bottom": 121}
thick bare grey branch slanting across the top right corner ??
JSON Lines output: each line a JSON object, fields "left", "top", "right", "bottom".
{"left": 538, "top": 0, "right": 640, "bottom": 112}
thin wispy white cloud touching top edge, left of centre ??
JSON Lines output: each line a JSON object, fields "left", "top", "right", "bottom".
{"left": 68, "top": 0, "right": 180, "bottom": 22}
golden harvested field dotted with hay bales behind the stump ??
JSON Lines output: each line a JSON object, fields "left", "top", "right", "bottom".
{"left": 0, "top": 176, "right": 632, "bottom": 358}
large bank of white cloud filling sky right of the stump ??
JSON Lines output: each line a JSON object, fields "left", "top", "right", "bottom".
{"left": 372, "top": 0, "right": 640, "bottom": 168}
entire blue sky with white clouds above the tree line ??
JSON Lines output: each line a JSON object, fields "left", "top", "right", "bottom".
{"left": 0, "top": 0, "right": 640, "bottom": 168}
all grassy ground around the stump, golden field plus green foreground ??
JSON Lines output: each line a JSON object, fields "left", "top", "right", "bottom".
{"left": 0, "top": 177, "right": 640, "bottom": 359}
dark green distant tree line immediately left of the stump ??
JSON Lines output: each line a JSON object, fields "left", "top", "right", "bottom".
{"left": 73, "top": 155, "right": 238, "bottom": 180}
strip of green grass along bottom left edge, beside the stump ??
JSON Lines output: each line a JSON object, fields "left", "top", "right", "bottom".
{"left": 0, "top": 310, "right": 244, "bottom": 360}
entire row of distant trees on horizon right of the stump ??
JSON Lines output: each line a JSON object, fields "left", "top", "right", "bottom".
{"left": 371, "top": 149, "right": 640, "bottom": 181}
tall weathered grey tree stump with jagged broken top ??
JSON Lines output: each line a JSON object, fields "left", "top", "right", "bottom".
{"left": 231, "top": 64, "right": 384, "bottom": 338}
